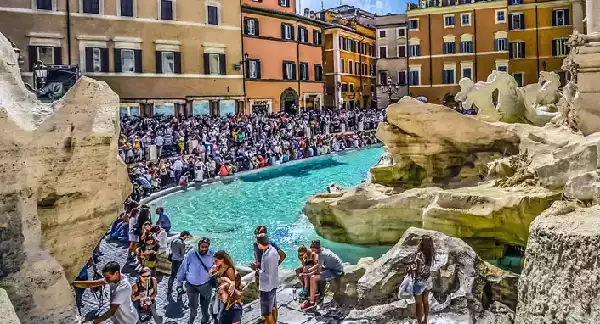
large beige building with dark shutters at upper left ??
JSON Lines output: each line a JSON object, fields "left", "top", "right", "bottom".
{"left": 0, "top": 0, "right": 244, "bottom": 115}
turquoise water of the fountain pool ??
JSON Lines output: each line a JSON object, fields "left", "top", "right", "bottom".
{"left": 152, "top": 148, "right": 389, "bottom": 269}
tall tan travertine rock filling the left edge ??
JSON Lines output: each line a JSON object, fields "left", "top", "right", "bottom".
{"left": 0, "top": 34, "right": 131, "bottom": 323}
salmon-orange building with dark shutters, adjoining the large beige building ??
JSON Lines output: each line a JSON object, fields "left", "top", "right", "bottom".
{"left": 242, "top": 0, "right": 324, "bottom": 113}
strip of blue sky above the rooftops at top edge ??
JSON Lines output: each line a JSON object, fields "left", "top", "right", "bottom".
{"left": 296, "top": 0, "right": 406, "bottom": 14}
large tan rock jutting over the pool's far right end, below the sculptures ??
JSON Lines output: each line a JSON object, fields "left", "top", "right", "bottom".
{"left": 371, "top": 97, "right": 519, "bottom": 188}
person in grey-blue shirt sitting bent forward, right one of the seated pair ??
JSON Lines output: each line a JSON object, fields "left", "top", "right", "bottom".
{"left": 300, "top": 240, "right": 344, "bottom": 310}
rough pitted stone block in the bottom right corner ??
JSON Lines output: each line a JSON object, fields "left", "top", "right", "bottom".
{"left": 515, "top": 202, "right": 600, "bottom": 324}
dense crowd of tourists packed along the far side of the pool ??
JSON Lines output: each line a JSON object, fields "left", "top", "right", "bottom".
{"left": 119, "top": 109, "right": 385, "bottom": 195}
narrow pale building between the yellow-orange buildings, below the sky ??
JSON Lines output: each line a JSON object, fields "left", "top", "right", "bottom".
{"left": 375, "top": 14, "right": 408, "bottom": 108}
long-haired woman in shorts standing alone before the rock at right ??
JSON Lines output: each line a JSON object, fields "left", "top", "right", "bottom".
{"left": 408, "top": 235, "right": 435, "bottom": 324}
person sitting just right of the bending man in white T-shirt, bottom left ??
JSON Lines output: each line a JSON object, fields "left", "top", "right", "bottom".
{"left": 131, "top": 267, "right": 163, "bottom": 324}
